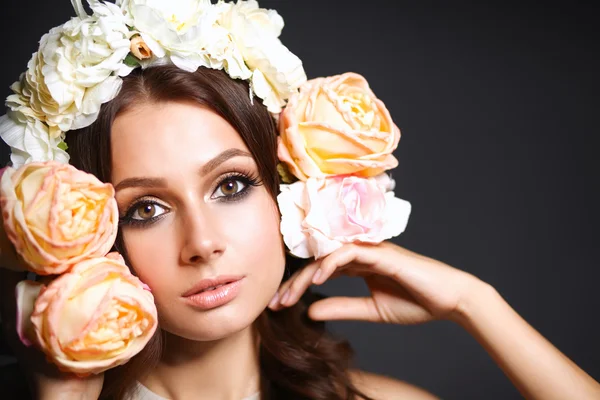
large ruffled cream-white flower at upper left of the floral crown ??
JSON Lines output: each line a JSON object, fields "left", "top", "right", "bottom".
{"left": 7, "top": 0, "right": 131, "bottom": 134}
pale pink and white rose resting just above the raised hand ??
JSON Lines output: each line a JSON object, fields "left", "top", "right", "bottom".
{"left": 277, "top": 174, "right": 411, "bottom": 259}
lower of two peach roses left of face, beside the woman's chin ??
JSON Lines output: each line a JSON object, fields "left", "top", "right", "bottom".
{"left": 17, "top": 253, "right": 157, "bottom": 376}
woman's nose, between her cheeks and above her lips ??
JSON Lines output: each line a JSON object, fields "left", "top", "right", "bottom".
{"left": 181, "top": 206, "right": 226, "bottom": 265}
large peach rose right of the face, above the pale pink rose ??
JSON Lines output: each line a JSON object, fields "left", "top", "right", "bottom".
{"left": 278, "top": 73, "right": 400, "bottom": 180}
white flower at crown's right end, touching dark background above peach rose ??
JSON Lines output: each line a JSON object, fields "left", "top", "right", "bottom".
{"left": 219, "top": 0, "right": 306, "bottom": 113}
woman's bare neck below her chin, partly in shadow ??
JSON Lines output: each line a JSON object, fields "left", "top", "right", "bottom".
{"left": 141, "top": 326, "right": 260, "bottom": 400}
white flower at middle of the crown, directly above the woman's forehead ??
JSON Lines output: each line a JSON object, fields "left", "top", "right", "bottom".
{"left": 121, "top": 0, "right": 233, "bottom": 75}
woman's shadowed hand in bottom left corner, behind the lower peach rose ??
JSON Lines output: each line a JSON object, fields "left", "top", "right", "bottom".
{"left": 0, "top": 266, "right": 104, "bottom": 400}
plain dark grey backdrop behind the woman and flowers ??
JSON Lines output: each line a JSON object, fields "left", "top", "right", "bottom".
{"left": 0, "top": 0, "right": 600, "bottom": 399}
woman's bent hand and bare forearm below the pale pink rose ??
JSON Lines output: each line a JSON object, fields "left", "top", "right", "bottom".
{"left": 269, "top": 243, "right": 600, "bottom": 400}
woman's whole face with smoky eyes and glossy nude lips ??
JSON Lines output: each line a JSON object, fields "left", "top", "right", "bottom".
{"left": 111, "top": 102, "right": 285, "bottom": 341}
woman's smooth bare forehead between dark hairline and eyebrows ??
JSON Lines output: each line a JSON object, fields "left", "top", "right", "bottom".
{"left": 111, "top": 102, "right": 248, "bottom": 182}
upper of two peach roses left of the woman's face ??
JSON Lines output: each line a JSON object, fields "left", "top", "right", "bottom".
{"left": 0, "top": 161, "right": 119, "bottom": 275}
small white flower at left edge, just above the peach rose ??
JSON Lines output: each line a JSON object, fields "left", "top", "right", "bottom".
{"left": 0, "top": 111, "right": 69, "bottom": 168}
